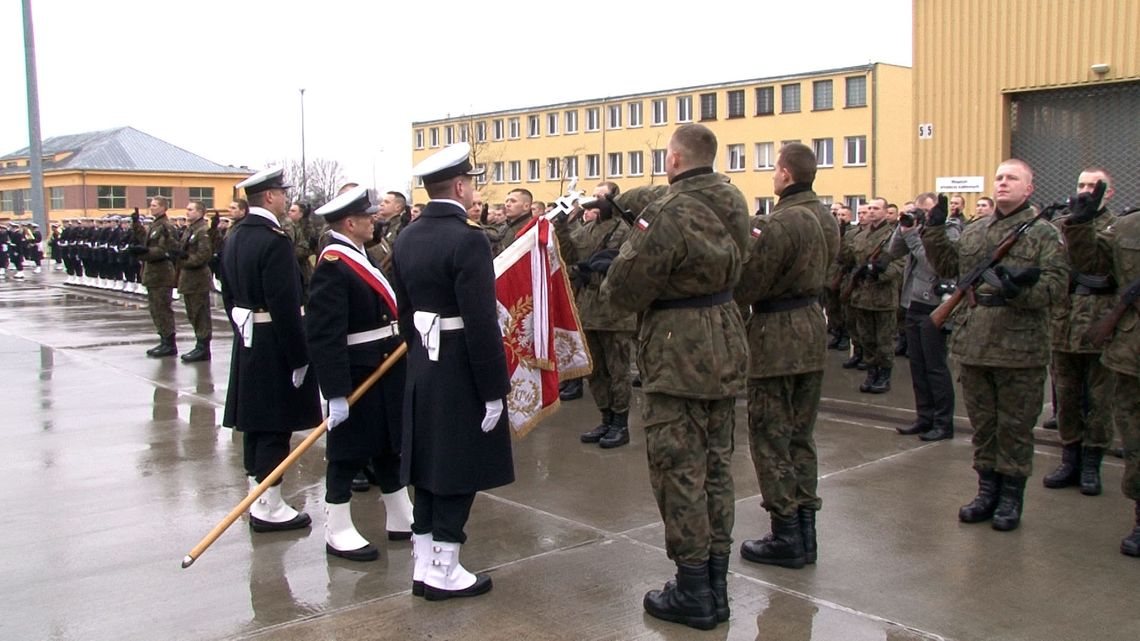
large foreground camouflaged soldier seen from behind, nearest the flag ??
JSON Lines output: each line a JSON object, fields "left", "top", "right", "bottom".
{"left": 602, "top": 124, "right": 749, "bottom": 630}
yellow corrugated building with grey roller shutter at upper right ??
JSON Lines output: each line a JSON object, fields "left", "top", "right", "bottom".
{"left": 912, "top": 0, "right": 1140, "bottom": 209}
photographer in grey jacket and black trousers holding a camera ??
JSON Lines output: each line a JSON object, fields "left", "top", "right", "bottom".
{"left": 888, "top": 192, "right": 962, "bottom": 440}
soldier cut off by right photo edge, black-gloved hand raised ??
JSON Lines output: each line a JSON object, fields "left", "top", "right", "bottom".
{"left": 1062, "top": 175, "right": 1140, "bottom": 557}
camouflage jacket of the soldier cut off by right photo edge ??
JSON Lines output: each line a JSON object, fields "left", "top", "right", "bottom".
{"left": 1061, "top": 213, "right": 1140, "bottom": 376}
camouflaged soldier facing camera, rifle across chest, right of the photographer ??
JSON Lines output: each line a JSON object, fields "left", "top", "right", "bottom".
{"left": 922, "top": 159, "right": 1068, "bottom": 530}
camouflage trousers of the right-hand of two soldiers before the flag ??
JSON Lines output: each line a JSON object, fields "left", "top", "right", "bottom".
{"left": 748, "top": 372, "right": 823, "bottom": 518}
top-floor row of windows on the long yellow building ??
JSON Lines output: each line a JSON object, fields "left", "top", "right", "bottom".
{"left": 415, "top": 75, "right": 866, "bottom": 149}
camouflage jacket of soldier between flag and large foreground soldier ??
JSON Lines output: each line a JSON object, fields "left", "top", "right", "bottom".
{"left": 554, "top": 216, "right": 637, "bottom": 332}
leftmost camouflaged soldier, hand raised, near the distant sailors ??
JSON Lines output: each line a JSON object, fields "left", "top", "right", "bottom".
{"left": 129, "top": 196, "right": 178, "bottom": 358}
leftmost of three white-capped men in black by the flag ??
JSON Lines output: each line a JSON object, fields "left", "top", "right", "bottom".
{"left": 220, "top": 169, "right": 320, "bottom": 532}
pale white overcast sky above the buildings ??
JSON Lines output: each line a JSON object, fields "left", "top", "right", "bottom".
{"left": 0, "top": 0, "right": 911, "bottom": 189}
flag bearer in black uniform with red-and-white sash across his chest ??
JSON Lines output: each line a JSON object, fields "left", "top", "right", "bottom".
{"left": 304, "top": 187, "right": 412, "bottom": 561}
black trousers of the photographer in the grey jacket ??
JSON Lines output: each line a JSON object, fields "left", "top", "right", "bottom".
{"left": 906, "top": 301, "right": 954, "bottom": 429}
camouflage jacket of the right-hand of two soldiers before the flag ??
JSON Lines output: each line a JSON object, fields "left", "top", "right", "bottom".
{"left": 734, "top": 187, "right": 839, "bottom": 379}
